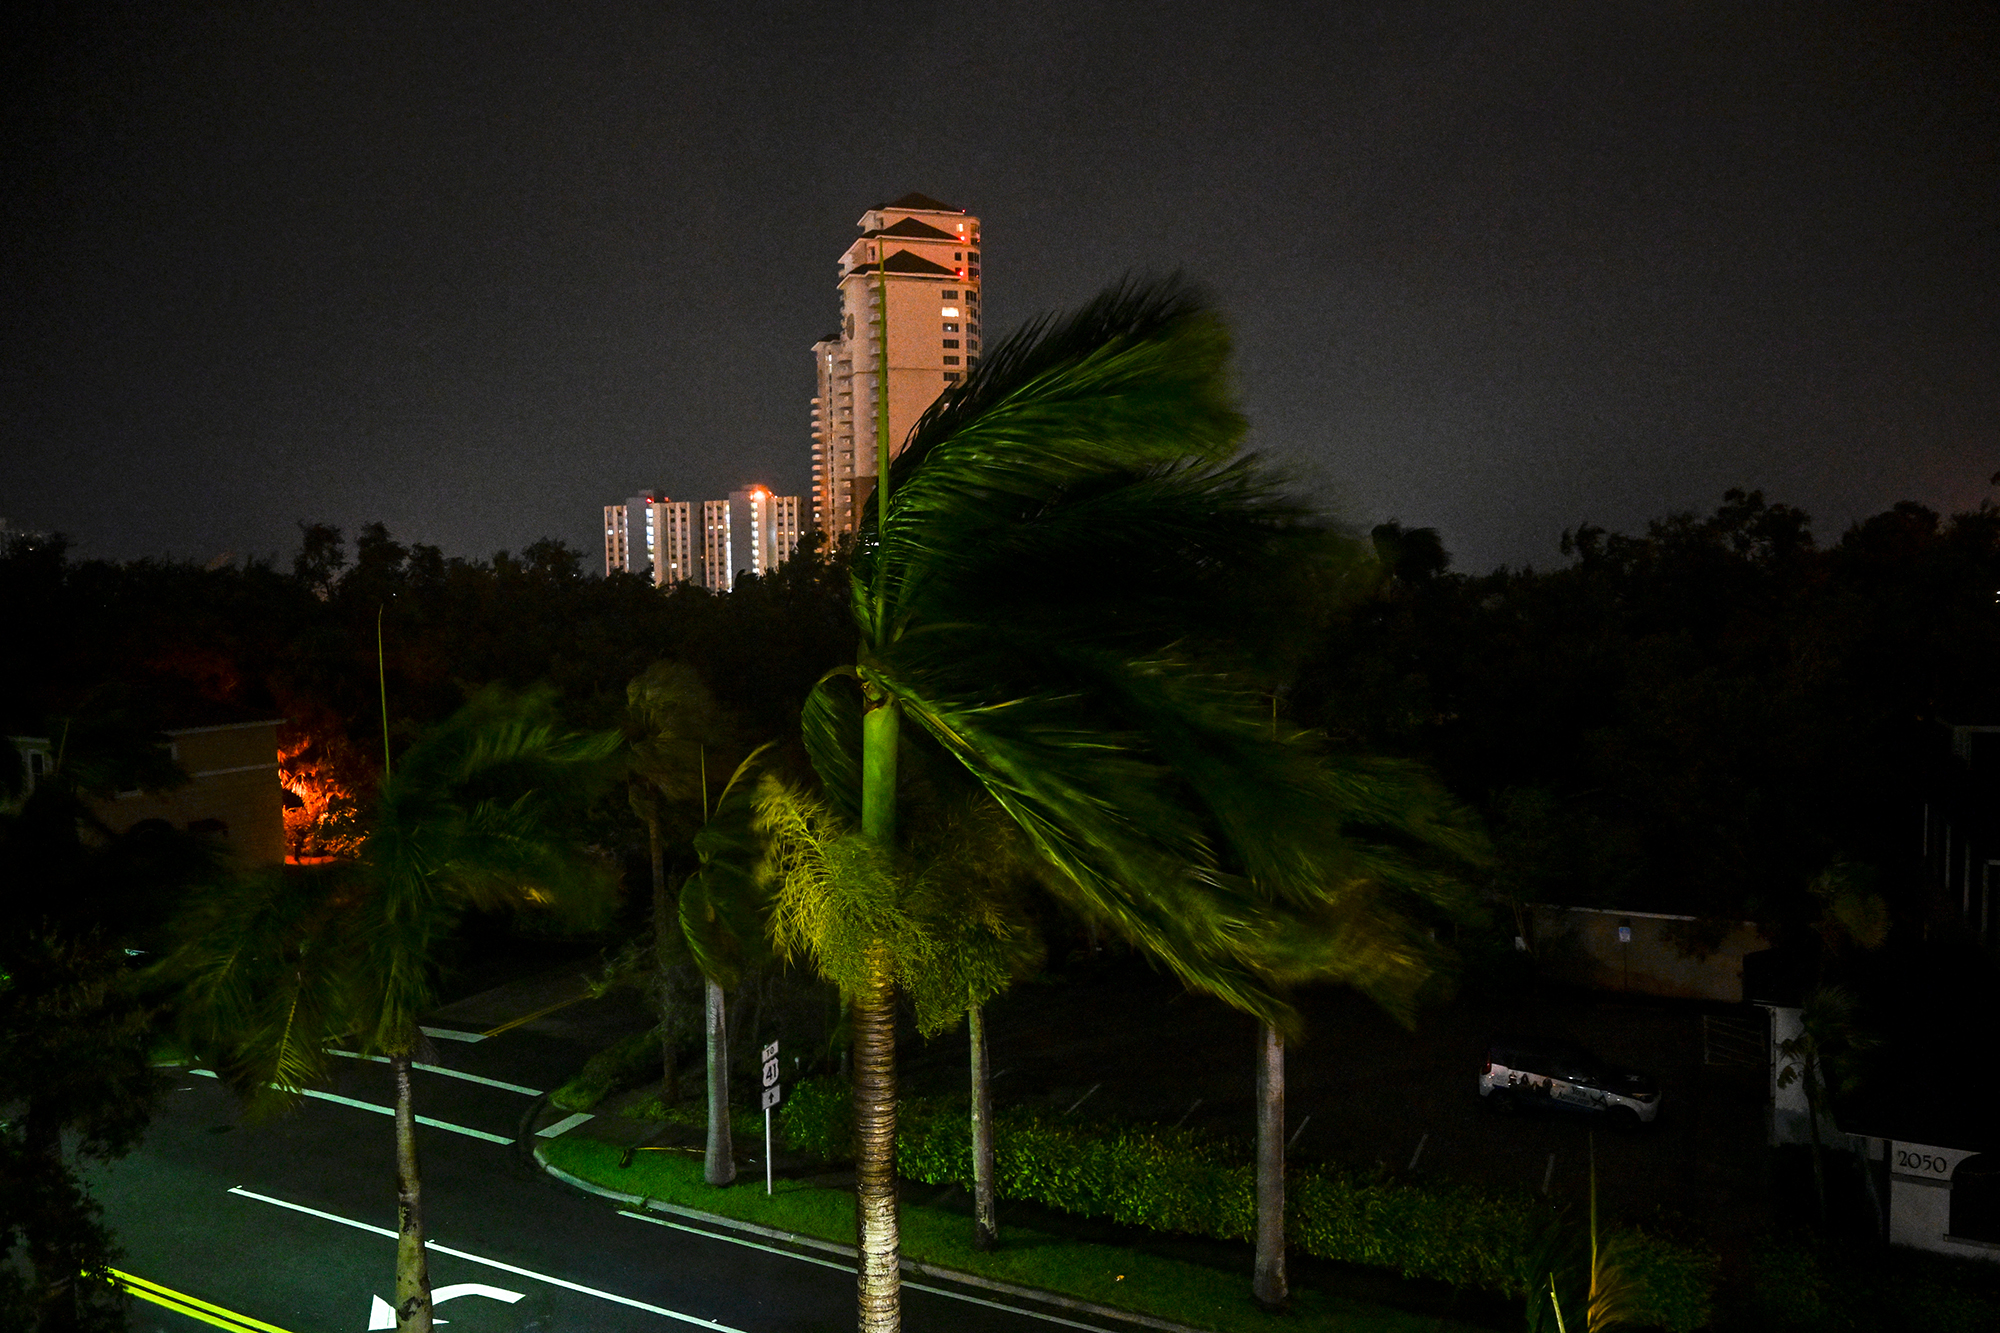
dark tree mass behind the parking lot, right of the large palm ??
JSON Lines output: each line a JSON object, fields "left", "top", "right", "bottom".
{"left": 1292, "top": 490, "right": 2000, "bottom": 921}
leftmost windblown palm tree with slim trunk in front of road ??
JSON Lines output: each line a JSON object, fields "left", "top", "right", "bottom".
{"left": 164, "top": 693, "right": 618, "bottom": 1333}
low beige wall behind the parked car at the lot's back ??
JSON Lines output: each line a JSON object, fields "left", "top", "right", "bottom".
{"left": 1528, "top": 903, "right": 1766, "bottom": 1005}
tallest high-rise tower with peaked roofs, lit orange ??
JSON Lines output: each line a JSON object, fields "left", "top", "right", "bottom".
{"left": 812, "top": 194, "right": 980, "bottom": 538}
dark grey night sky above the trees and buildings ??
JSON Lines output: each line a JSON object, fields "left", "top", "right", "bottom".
{"left": 0, "top": 0, "right": 2000, "bottom": 570}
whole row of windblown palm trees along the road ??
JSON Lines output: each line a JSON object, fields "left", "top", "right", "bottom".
{"left": 174, "top": 282, "right": 1484, "bottom": 1333}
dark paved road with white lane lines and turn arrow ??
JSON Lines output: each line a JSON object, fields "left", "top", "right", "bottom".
{"left": 96, "top": 976, "right": 1128, "bottom": 1333}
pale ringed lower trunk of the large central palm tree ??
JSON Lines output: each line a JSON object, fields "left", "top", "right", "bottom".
{"left": 854, "top": 949, "right": 902, "bottom": 1333}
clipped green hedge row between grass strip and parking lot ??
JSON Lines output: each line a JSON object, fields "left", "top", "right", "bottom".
{"left": 784, "top": 1079, "right": 1716, "bottom": 1333}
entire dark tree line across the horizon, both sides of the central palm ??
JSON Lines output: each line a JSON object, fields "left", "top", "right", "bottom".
{"left": 15, "top": 490, "right": 2000, "bottom": 932}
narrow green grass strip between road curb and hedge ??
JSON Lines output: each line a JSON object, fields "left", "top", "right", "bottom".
{"left": 542, "top": 1137, "right": 1474, "bottom": 1333}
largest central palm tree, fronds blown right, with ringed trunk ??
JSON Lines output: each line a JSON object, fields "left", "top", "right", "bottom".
{"left": 780, "top": 282, "right": 1488, "bottom": 1331}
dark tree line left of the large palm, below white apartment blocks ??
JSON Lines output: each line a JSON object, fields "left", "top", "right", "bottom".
{"left": 0, "top": 524, "right": 852, "bottom": 800}
